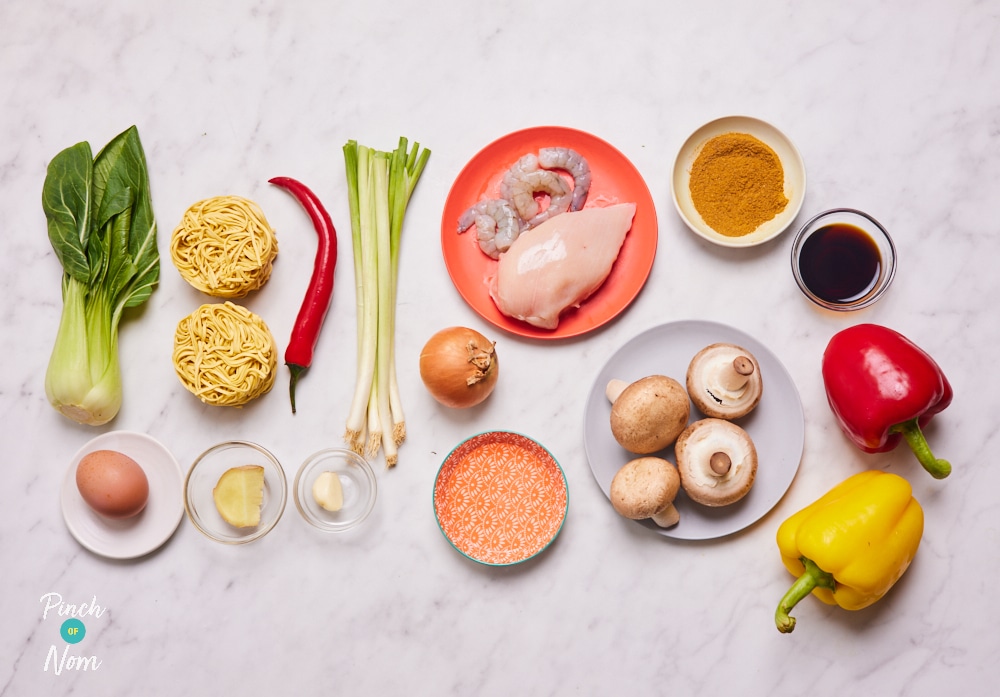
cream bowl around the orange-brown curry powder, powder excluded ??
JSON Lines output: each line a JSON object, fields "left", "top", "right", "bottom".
{"left": 671, "top": 116, "right": 806, "bottom": 247}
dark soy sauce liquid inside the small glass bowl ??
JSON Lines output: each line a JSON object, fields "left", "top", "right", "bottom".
{"left": 799, "top": 223, "right": 882, "bottom": 303}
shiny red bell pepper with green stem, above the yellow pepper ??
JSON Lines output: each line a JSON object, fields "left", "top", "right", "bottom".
{"left": 823, "top": 324, "right": 952, "bottom": 479}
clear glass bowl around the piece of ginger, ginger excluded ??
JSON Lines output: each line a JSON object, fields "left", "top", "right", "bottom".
{"left": 184, "top": 440, "right": 287, "bottom": 545}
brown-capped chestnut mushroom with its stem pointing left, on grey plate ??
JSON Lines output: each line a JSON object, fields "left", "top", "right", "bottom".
{"left": 605, "top": 375, "right": 691, "bottom": 455}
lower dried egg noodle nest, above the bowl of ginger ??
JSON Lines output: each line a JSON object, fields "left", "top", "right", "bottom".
{"left": 173, "top": 302, "right": 278, "bottom": 406}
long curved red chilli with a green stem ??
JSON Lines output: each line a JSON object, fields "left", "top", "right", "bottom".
{"left": 268, "top": 177, "right": 337, "bottom": 414}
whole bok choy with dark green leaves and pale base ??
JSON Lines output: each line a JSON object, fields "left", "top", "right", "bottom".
{"left": 42, "top": 126, "right": 160, "bottom": 426}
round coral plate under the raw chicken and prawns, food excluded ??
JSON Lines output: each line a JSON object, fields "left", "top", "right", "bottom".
{"left": 441, "top": 126, "right": 658, "bottom": 339}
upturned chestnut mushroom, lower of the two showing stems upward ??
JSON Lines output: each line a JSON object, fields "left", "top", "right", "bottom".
{"left": 674, "top": 418, "right": 757, "bottom": 506}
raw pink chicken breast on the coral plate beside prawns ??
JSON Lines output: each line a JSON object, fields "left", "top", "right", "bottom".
{"left": 490, "top": 203, "right": 635, "bottom": 329}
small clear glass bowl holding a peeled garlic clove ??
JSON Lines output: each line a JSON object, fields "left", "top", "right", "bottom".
{"left": 292, "top": 448, "right": 378, "bottom": 532}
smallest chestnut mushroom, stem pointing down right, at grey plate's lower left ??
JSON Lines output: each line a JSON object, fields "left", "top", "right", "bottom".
{"left": 611, "top": 457, "right": 681, "bottom": 528}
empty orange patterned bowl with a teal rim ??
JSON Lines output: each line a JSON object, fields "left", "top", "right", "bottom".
{"left": 434, "top": 431, "right": 569, "bottom": 566}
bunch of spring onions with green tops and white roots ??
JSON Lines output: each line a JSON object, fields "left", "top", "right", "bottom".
{"left": 344, "top": 138, "right": 430, "bottom": 467}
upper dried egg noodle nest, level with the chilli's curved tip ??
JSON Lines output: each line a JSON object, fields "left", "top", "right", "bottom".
{"left": 170, "top": 196, "right": 278, "bottom": 298}
